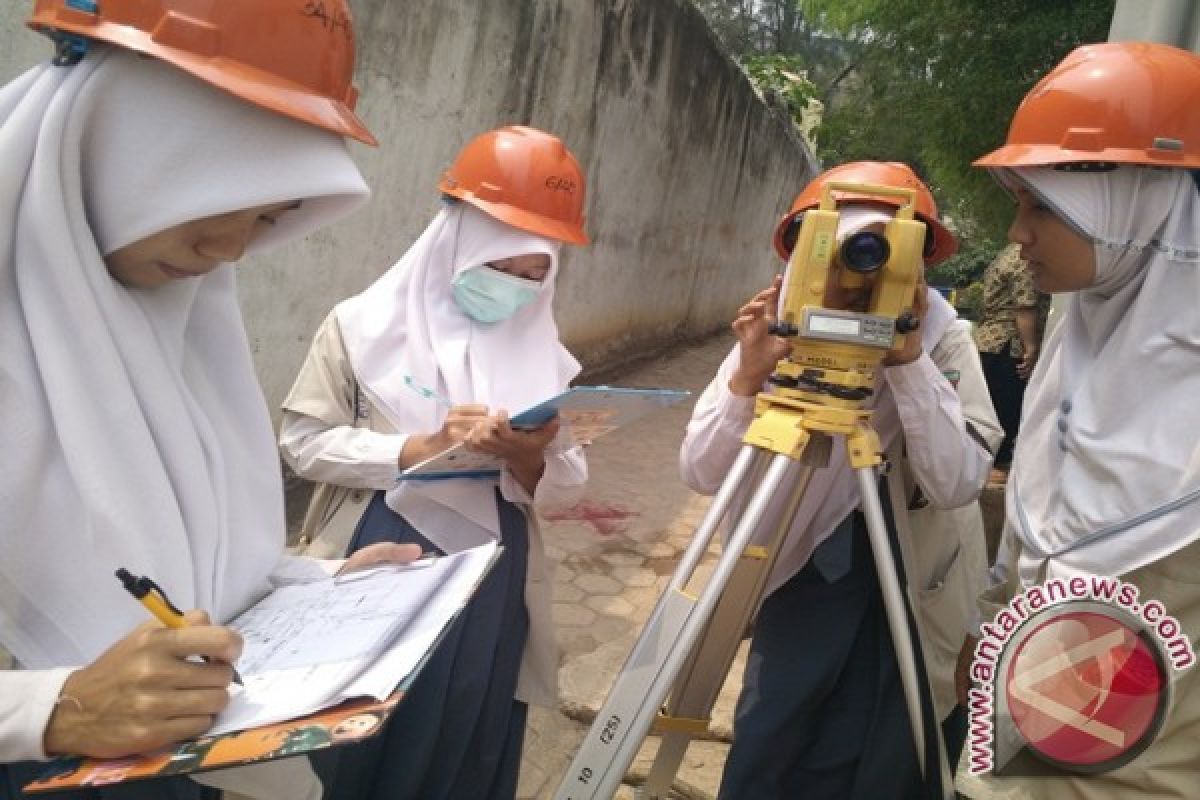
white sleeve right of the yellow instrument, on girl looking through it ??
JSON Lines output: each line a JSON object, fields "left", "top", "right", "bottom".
{"left": 883, "top": 338, "right": 991, "bottom": 509}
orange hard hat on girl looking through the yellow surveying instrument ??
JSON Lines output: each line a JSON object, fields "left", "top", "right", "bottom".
{"left": 775, "top": 161, "right": 959, "bottom": 266}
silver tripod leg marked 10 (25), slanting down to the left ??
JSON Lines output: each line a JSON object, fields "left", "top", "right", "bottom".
{"left": 554, "top": 446, "right": 794, "bottom": 800}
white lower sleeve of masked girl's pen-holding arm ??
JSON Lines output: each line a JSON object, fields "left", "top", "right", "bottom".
{"left": 280, "top": 411, "right": 408, "bottom": 489}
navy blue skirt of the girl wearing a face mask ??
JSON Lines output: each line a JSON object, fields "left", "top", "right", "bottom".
{"left": 312, "top": 491, "right": 529, "bottom": 800}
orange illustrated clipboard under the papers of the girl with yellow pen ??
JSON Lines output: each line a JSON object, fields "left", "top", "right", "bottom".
{"left": 23, "top": 547, "right": 502, "bottom": 794}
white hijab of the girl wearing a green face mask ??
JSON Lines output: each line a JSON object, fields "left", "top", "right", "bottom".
{"left": 336, "top": 203, "right": 580, "bottom": 552}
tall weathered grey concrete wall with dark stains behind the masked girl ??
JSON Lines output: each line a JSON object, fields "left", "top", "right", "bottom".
{"left": 0, "top": 0, "right": 812, "bottom": 422}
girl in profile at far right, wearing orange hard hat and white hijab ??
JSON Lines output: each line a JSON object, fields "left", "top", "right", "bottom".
{"left": 959, "top": 43, "right": 1200, "bottom": 798}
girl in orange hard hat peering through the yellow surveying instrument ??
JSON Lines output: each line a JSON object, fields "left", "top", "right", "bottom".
{"left": 679, "top": 161, "right": 1001, "bottom": 800}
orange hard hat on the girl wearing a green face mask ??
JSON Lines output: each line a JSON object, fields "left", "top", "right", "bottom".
{"left": 438, "top": 125, "right": 588, "bottom": 245}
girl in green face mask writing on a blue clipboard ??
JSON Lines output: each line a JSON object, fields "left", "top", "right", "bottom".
{"left": 281, "top": 126, "right": 587, "bottom": 800}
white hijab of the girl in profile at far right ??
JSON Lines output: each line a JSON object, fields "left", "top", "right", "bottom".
{"left": 1000, "top": 167, "right": 1200, "bottom": 584}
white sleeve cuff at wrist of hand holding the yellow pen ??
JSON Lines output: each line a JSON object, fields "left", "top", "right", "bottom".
{"left": 0, "top": 667, "right": 74, "bottom": 764}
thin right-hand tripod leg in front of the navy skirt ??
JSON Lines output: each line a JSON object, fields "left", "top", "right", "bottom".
{"left": 854, "top": 467, "right": 954, "bottom": 798}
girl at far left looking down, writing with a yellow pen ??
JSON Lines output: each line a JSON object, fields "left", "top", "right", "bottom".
{"left": 0, "top": 0, "right": 410, "bottom": 798}
